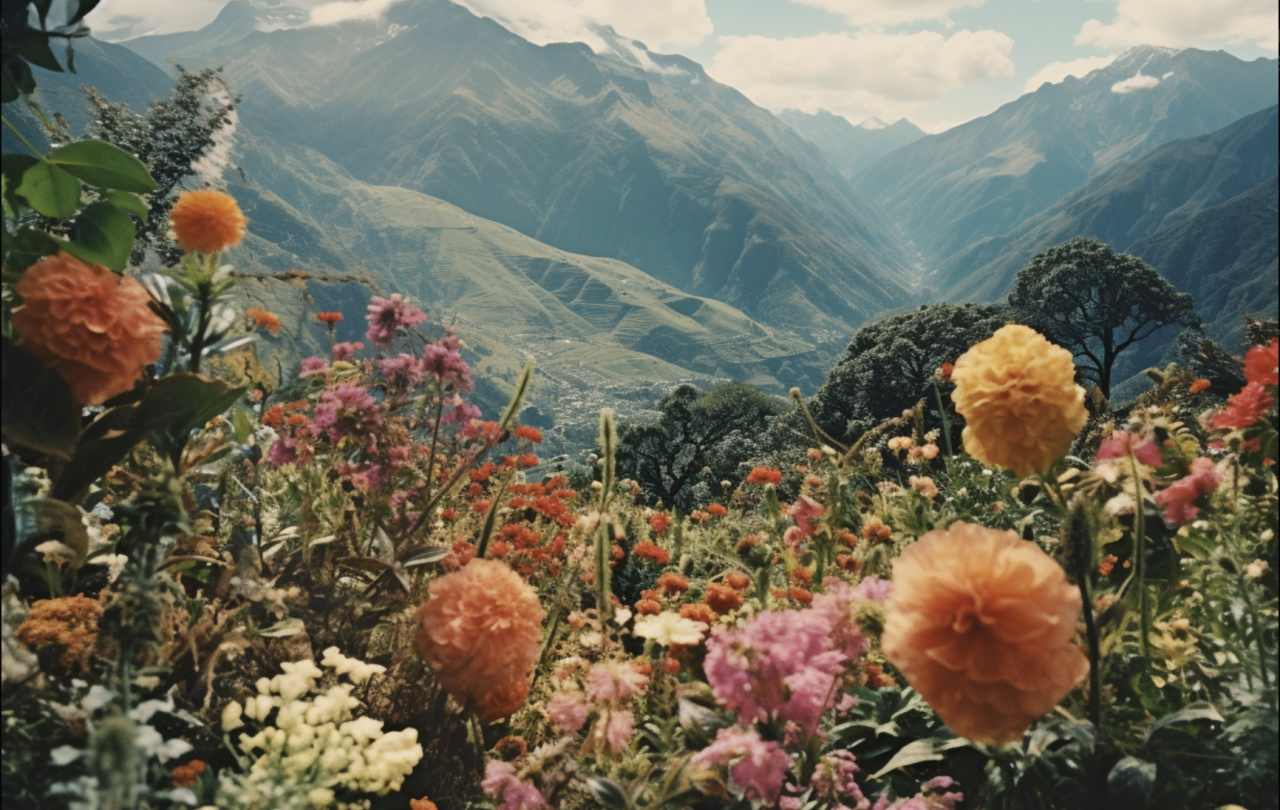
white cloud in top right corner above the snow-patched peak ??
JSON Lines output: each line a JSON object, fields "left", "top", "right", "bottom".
{"left": 1075, "top": 0, "right": 1280, "bottom": 51}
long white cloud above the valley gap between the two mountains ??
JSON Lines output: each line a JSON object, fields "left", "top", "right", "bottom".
{"left": 707, "top": 31, "right": 1014, "bottom": 120}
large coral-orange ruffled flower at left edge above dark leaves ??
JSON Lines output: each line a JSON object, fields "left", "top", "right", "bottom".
{"left": 13, "top": 253, "right": 166, "bottom": 406}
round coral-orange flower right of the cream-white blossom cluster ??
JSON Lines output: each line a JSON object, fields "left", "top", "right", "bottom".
{"left": 413, "top": 558, "right": 547, "bottom": 713}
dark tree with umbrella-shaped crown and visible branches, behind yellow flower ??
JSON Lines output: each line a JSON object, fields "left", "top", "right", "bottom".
{"left": 1009, "top": 237, "right": 1201, "bottom": 397}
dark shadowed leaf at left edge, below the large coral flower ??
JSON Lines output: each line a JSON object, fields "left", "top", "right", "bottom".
{"left": 0, "top": 338, "right": 81, "bottom": 461}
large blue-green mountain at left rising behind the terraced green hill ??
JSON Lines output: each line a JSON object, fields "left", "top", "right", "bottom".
{"left": 124, "top": 0, "right": 915, "bottom": 333}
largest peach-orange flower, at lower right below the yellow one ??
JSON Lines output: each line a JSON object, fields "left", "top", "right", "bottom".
{"left": 882, "top": 522, "right": 1089, "bottom": 745}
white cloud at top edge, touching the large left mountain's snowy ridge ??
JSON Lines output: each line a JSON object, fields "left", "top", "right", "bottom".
{"left": 458, "top": 0, "right": 713, "bottom": 51}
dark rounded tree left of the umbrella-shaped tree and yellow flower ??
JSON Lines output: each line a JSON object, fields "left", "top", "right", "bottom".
{"left": 810, "top": 303, "right": 1011, "bottom": 441}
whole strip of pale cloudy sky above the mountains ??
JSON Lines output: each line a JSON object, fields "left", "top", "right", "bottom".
{"left": 90, "top": 0, "right": 1280, "bottom": 132}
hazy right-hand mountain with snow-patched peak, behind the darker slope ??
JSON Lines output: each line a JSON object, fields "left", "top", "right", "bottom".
{"left": 855, "top": 46, "right": 1277, "bottom": 262}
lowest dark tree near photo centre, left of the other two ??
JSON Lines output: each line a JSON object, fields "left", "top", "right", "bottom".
{"left": 617, "top": 383, "right": 787, "bottom": 511}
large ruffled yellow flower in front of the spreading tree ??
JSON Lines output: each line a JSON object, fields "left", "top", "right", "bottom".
{"left": 951, "top": 324, "right": 1088, "bottom": 476}
